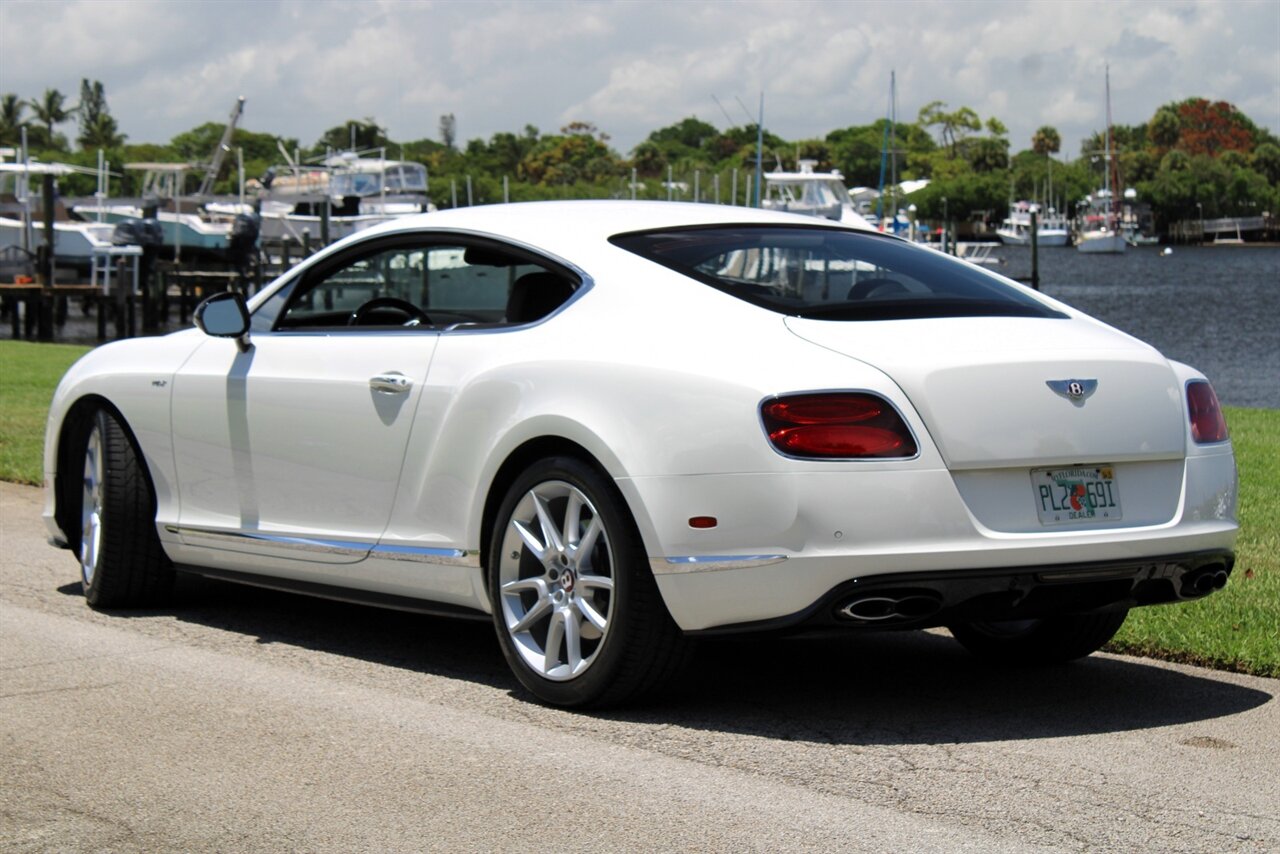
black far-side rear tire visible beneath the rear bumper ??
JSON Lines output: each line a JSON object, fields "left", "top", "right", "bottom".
{"left": 948, "top": 608, "right": 1129, "bottom": 665}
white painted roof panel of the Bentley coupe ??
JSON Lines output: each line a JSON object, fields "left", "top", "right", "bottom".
{"left": 361, "top": 200, "right": 870, "bottom": 251}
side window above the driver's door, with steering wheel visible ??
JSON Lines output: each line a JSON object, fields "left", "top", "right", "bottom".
{"left": 272, "top": 238, "right": 577, "bottom": 332}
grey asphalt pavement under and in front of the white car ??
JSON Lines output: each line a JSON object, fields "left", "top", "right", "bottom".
{"left": 0, "top": 484, "right": 1280, "bottom": 853}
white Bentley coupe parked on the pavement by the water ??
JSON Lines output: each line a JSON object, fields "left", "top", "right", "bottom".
{"left": 45, "top": 202, "right": 1236, "bottom": 705}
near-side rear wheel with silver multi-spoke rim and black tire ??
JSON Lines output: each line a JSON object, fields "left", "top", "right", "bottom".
{"left": 488, "top": 457, "right": 689, "bottom": 708}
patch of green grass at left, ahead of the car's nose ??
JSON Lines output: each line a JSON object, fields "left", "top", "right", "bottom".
{"left": 0, "top": 341, "right": 91, "bottom": 487}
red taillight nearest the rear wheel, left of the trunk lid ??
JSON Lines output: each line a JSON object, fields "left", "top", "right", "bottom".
{"left": 760, "top": 393, "right": 915, "bottom": 460}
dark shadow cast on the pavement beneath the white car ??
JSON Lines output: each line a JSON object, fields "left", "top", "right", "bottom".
{"left": 59, "top": 576, "right": 1274, "bottom": 745}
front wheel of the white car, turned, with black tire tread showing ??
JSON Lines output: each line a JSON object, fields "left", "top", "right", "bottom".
{"left": 78, "top": 410, "right": 174, "bottom": 608}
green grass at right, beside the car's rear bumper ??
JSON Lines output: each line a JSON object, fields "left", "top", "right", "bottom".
{"left": 1108, "top": 407, "right": 1280, "bottom": 676}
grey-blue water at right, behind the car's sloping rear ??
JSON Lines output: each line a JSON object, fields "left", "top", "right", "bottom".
{"left": 995, "top": 246, "right": 1280, "bottom": 408}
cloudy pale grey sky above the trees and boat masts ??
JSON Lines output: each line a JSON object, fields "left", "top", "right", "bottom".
{"left": 0, "top": 0, "right": 1280, "bottom": 156}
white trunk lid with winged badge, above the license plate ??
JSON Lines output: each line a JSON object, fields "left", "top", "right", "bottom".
{"left": 786, "top": 318, "right": 1185, "bottom": 469}
